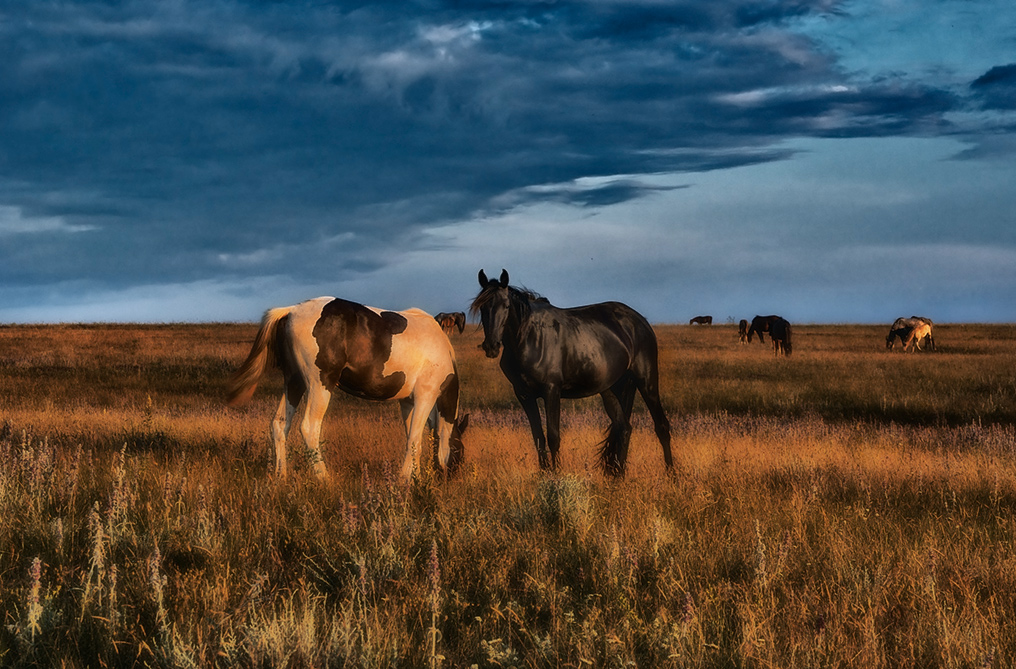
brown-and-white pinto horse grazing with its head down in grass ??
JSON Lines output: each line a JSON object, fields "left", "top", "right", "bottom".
{"left": 228, "top": 297, "right": 468, "bottom": 479}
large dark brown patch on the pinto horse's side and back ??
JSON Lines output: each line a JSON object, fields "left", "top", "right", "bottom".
{"left": 314, "top": 298, "right": 408, "bottom": 400}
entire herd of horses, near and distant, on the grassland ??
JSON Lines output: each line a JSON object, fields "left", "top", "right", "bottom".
{"left": 227, "top": 269, "right": 935, "bottom": 481}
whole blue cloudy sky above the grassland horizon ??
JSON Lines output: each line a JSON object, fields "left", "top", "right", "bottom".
{"left": 0, "top": 0, "right": 1016, "bottom": 323}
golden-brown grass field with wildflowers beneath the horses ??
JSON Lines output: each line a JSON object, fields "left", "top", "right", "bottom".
{"left": 0, "top": 324, "right": 1016, "bottom": 667}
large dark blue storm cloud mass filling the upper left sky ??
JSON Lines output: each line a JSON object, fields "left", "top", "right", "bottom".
{"left": 0, "top": 0, "right": 975, "bottom": 294}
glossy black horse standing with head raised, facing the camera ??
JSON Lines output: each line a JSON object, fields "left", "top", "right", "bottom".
{"left": 470, "top": 269, "right": 674, "bottom": 477}
